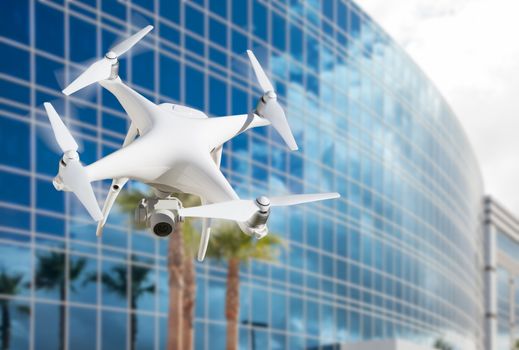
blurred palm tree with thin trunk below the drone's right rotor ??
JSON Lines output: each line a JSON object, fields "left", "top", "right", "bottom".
{"left": 207, "top": 223, "right": 283, "bottom": 350}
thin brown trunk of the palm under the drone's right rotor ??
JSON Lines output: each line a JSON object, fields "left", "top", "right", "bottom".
{"left": 225, "top": 258, "right": 240, "bottom": 350}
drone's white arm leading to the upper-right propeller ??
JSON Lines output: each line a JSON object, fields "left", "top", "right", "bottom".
{"left": 205, "top": 113, "right": 270, "bottom": 149}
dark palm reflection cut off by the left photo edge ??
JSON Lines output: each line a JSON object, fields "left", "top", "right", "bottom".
{"left": 0, "top": 268, "right": 23, "bottom": 350}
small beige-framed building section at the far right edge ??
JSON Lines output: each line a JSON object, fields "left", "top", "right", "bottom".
{"left": 485, "top": 197, "right": 519, "bottom": 350}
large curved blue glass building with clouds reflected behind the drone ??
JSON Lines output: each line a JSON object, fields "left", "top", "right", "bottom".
{"left": 0, "top": 0, "right": 484, "bottom": 350}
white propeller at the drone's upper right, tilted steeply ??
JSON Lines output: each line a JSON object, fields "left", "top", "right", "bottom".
{"left": 247, "top": 50, "right": 298, "bottom": 151}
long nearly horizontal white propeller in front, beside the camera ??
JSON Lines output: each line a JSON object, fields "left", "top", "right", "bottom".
{"left": 179, "top": 192, "right": 340, "bottom": 222}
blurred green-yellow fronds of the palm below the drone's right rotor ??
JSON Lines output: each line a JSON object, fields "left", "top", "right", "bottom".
{"left": 207, "top": 223, "right": 284, "bottom": 263}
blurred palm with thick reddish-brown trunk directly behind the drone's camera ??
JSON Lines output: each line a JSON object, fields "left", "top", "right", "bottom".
{"left": 117, "top": 190, "right": 199, "bottom": 350}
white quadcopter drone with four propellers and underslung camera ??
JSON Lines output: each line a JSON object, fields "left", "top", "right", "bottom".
{"left": 44, "top": 26, "right": 339, "bottom": 261}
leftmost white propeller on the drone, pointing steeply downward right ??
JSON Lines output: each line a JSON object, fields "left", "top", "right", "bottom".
{"left": 44, "top": 102, "right": 103, "bottom": 221}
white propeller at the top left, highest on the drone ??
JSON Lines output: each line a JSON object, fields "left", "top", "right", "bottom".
{"left": 63, "top": 25, "right": 153, "bottom": 95}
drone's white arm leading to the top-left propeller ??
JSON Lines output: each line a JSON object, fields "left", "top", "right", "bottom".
{"left": 99, "top": 77, "right": 158, "bottom": 134}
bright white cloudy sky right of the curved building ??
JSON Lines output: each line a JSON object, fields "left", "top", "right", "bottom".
{"left": 357, "top": 0, "right": 519, "bottom": 215}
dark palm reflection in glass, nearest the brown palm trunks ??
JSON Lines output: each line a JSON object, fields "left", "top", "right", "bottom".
{"left": 97, "top": 259, "right": 155, "bottom": 350}
